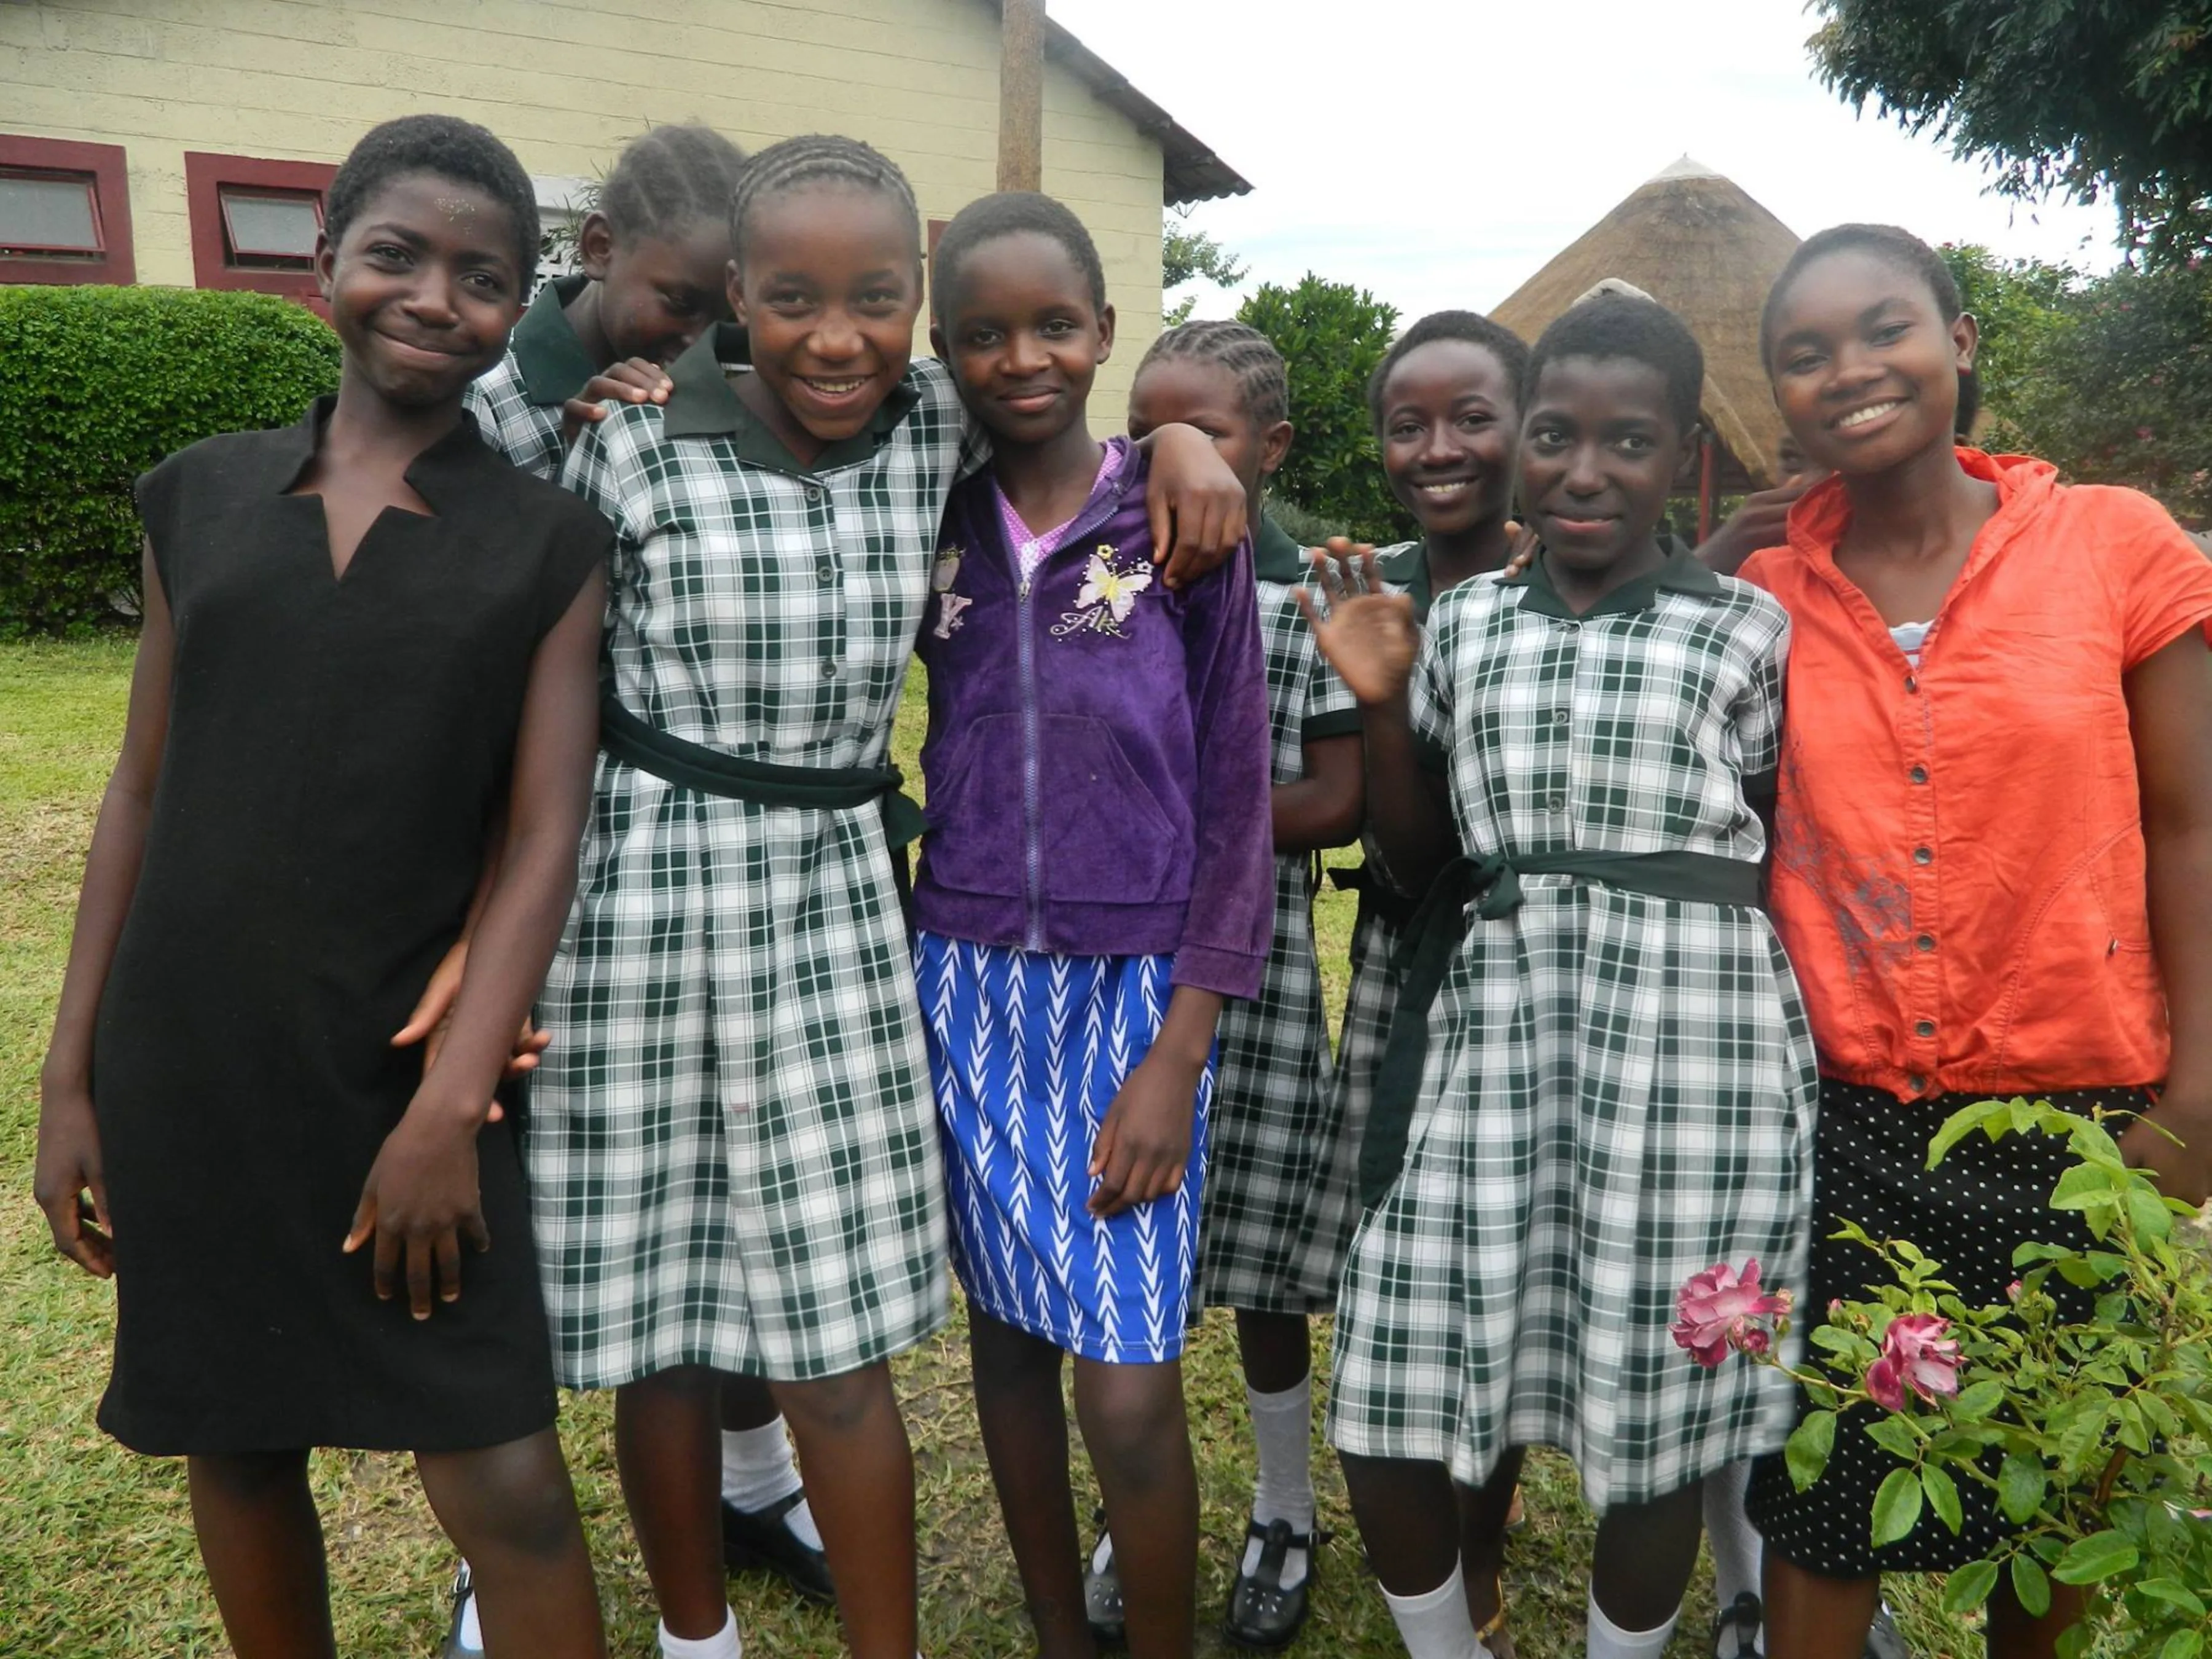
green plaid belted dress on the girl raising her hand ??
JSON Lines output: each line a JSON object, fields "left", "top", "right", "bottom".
{"left": 1330, "top": 553, "right": 1816, "bottom": 1511}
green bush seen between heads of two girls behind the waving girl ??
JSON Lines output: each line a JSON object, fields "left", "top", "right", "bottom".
{"left": 1236, "top": 272, "right": 1413, "bottom": 542}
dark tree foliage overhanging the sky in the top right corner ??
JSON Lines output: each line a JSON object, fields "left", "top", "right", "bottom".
{"left": 1811, "top": 0, "right": 2212, "bottom": 263}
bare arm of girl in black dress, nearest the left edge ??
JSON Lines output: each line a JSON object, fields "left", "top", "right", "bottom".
{"left": 33, "top": 542, "right": 177, "bottom": 1279}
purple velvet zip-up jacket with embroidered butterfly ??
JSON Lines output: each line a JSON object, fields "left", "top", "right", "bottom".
{"left": 914, "top": 438, "right": 1274, "bottom": 998}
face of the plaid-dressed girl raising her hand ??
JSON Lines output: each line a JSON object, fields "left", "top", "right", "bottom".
{"left": 1520, "top": 356, "right": 1696, "bottom": 578}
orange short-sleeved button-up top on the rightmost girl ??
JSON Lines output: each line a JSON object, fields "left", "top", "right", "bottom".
{"left": 1743, "top": 449, "right": 2212, "bottom": 1099}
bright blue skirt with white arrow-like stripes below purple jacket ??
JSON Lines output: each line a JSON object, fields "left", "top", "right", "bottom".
{"left": 914, "top": 933, "right": 1214, "bottom": 1365}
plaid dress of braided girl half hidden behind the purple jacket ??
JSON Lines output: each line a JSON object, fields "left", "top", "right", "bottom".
{"left": 1199, "top": 520, "right": 1360, "bottom": 1314}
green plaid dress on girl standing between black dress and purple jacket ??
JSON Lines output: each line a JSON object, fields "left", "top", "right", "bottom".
{"left": 527, "top": 325, "right": 982, "bottom": 1387}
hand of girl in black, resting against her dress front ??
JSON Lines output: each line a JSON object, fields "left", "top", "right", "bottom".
{"left": 345, "top": 1095, "right": 491, "bottom": 1319}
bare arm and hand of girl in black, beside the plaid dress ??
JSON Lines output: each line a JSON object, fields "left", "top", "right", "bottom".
{"left": 345, "top": 575, "right": 604, "bottom": 1319}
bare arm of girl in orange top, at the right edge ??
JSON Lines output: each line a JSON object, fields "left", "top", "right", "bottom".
{"left": 2121, "top": 628, "right": 2212, "bottom": 1203}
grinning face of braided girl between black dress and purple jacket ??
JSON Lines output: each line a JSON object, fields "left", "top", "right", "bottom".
{"left": 730, "top": 184, "right": 922, "bottom": 445}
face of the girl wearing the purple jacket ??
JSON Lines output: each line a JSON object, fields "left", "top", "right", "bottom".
{"left": 929, "top": 230, "right": 1113, "bottom": 447}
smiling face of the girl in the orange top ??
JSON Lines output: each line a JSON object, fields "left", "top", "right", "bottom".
{"left": 1767, "top": 248, "right": 1977, "bottom": 476}
